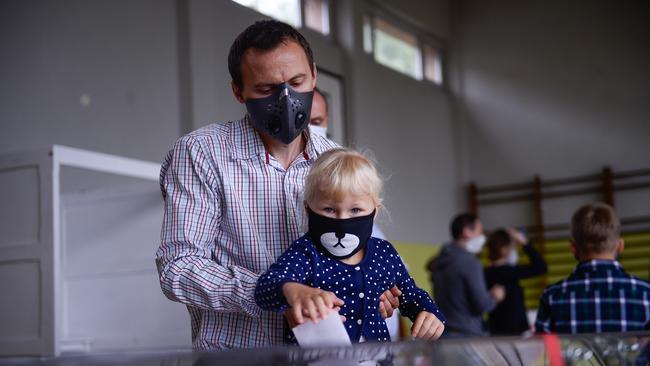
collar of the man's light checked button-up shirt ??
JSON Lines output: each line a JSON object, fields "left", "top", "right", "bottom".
{"left": 230, "top": 114, "right": 328, "bottom": 160}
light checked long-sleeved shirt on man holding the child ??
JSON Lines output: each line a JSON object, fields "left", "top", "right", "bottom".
{"left": 156, "top": 118, "right": 336, "bottom": 350}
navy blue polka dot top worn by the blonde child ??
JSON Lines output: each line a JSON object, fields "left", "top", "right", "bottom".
{"left": 255, "top": 235, "right": 445, "bottom": 343}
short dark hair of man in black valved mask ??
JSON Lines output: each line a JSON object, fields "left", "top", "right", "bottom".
{"left": 228, "top": 20, "right": 314, "bottom": 89}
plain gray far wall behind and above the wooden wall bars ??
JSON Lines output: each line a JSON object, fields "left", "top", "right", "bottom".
{"left": 453, "top": 0, "right": 650, "bottom": 227}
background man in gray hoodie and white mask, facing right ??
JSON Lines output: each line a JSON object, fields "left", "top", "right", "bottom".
{"left": 427, "top": 213, "right": 505, "bottom": 337}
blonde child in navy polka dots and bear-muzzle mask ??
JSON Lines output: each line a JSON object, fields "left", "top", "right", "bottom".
{"left": 255, "top": 149, "right": 444, "bottom": 342}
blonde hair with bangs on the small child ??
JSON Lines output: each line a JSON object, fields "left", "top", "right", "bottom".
{"left": 305, "top": 148, "right": 383, "bottom": 206}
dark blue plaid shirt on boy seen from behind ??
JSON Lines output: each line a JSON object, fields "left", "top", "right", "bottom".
{"left": 535, "top": 260, "right": 650, "bottom": 333}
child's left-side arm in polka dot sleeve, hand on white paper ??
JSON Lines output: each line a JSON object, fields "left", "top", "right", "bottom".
{"left": 255, "top": 243, "right": 343, "bottom": 324}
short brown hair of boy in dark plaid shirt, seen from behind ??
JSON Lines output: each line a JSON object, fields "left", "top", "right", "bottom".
{"left": 571, "top": 203, "right": 621, "bottom": 253}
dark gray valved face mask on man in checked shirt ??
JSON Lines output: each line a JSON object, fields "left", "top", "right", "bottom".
{"left": 246, "top": 83, "right": 314, "bottom": 144}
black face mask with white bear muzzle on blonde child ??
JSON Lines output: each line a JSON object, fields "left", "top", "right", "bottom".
{"left": 307, "top": 208, "right": 375, "bottom": 259}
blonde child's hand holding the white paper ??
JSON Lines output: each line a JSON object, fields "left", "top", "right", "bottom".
{"left": 282, "top": 282, "right": 344, "bottom": 325}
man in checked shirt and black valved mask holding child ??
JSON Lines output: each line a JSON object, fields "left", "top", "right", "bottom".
{"left": 156, "top": 20, "right": 399, "bottom": 350}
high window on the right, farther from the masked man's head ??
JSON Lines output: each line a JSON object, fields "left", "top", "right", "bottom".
{"left": 363, "top": 16, "right": 443, "bottom": 85}
